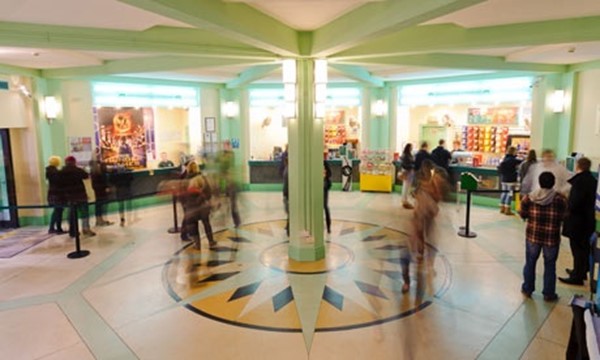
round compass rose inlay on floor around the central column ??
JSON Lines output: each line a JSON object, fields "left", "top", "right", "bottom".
{"left": 164, "top": 221, "right": 450, "bottom": 337}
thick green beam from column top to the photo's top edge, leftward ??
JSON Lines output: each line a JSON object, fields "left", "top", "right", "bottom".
{"left": 119, "top": 0, "right": 298, "bottom": 56}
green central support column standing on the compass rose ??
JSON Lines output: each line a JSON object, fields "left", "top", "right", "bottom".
{"left": 288, "top": 59, "right": 325, "bottom": 261}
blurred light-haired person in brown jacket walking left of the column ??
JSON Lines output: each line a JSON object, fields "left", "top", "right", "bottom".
{"left": 184, "top": 167, "right": 217, "bottom": 250}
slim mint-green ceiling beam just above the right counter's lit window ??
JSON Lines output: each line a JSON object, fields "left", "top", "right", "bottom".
{"left": 342, "top": 54, "right": 567, "bottom": 72}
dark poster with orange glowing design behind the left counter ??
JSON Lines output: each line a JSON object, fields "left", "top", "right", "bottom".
{"left": 94, "top": 107, "right": 154, "bottom": 169}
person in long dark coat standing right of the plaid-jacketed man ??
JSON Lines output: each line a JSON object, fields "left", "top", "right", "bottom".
{"left": 559, "top": 157, "right": 598, "bottom": 285}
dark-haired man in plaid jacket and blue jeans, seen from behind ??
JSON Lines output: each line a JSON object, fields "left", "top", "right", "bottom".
{"left": 520, "top": 172, "right": 567, "bottom": 301}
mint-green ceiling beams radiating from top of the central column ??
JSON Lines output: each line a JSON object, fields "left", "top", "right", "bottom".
{"left": 0, "top": 0, "right": 600, "bottom": 84}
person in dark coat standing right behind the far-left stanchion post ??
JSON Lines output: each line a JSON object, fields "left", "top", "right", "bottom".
{"left": 59, "top": 156, "right": 96, "bottom": 237}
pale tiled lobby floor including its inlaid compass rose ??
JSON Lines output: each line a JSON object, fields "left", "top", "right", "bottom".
{"left": 0, "top": 192, "right": 586, "bottom": 360}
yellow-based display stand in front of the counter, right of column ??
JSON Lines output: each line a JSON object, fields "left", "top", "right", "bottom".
{"left": 360, "top": 150, "right": 395, "bottom": 192}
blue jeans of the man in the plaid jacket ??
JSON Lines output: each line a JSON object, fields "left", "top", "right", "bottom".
{"left": 521, "top": 241, "right": 559, "bottom": 296}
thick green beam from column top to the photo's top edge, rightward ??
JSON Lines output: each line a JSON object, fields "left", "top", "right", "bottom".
{"left": 312, "top": 0, "right": 484, "bottom": 57}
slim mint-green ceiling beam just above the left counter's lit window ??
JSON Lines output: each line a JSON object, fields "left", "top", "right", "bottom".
{"left": 42, "top": 56, "right": 268, "bottom": 78}
